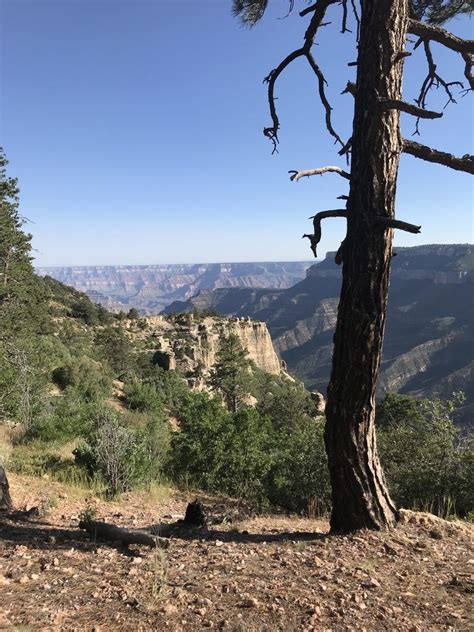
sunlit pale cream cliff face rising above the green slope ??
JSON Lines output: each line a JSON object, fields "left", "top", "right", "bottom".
{"left": 146, "top": 314, "right": 284, "bottom": 390}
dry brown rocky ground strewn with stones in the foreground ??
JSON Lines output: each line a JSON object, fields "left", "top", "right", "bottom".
{"left": 0, "top": 476, "right": 474, "bottom": 632}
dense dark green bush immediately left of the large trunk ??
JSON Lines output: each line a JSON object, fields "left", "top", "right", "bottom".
{"left": 170, "top": 394, "right": 329, "bottom": 510}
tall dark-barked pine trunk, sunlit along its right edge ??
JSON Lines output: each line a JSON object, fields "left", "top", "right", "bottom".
{"left": 325, "top": 0, "right": 408, "bottom": 532}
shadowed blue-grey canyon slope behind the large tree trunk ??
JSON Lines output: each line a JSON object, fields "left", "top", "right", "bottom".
{"left": 164, "top": 244, "right": 474, "bottom": 422}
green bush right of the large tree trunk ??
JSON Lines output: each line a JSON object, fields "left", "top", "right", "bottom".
{"left": 377, "top": 394, "right": 474, "bottom": 517}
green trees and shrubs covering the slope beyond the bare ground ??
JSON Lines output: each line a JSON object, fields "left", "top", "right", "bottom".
{"left": 0, "top": 151, "right": 474, "bottom": 516}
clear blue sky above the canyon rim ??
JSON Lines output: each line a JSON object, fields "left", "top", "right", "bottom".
{"left": 0, "top": 0, "right": 473, "bottom": 265}
